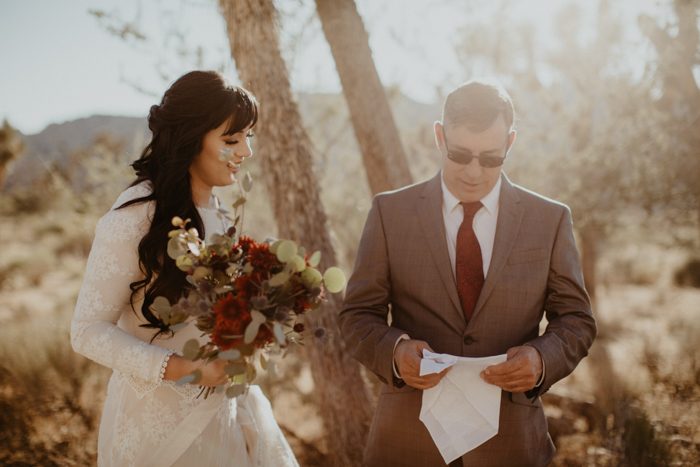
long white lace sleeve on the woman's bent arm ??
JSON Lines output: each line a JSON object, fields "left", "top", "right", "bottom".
{"left": 71, "top": 197, "right": 170, "bottom": 383}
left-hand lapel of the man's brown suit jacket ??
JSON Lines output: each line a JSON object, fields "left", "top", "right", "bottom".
{"left": 416, "top": 173, "right": 466, "bottom": 332}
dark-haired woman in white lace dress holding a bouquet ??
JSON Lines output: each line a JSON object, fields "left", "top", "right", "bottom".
{"left": 71, "top": 71, "right": 298, "bottom": 467}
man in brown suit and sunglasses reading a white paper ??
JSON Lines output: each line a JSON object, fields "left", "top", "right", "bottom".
{"left": 340, "top": 81, "right": 596, "bottom": 467}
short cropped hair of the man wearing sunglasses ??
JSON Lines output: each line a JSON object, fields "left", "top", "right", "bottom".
{"left": 442, "top": 80, "right": 514, "bottom": 131}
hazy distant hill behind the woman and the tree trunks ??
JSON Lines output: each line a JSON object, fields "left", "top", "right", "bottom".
{"left": 2, "top": 93, "right": 440, "bottom": 191}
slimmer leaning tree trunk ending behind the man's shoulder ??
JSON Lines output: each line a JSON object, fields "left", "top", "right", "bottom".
{"left": 316, "top": 0, "right": 412, "bottom": 193}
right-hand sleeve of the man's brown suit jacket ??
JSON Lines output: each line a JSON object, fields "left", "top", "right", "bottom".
{"left": 527, "top": 207, "right": 596, "bottom": 397}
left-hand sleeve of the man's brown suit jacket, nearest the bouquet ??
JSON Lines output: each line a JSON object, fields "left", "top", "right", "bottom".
{"left": 339, "top": 197, "right": 404, "bottom": 386}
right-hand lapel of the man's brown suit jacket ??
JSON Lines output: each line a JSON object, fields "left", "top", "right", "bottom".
{"left": 472, "top": 174, "right": 523, "bottom": 320}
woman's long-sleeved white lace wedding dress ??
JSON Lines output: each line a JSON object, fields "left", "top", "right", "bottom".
{"left": 71, "top": 182, "right": 298, "bottom": 467}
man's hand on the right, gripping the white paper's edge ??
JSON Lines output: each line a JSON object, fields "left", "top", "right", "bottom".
{"left": 481, "top": 345, "right": 542, "bottom": 392}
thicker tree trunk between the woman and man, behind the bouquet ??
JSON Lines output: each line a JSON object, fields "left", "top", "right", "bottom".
{"left": 219, "top": 0, "right": 371, "bottom": 466}
